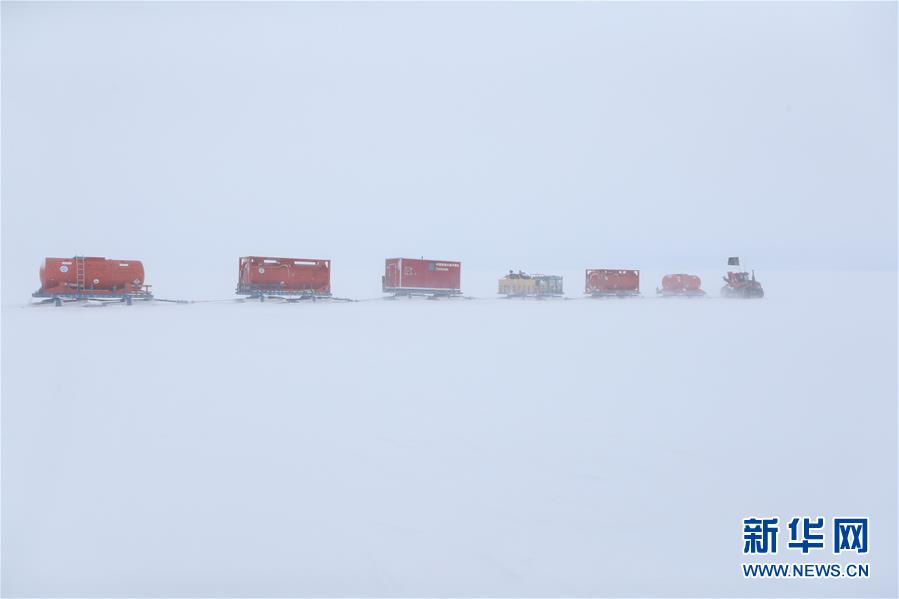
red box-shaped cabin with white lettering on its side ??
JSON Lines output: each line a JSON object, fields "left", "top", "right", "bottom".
{"left": 381, "top": 258, "right": 462, "bottom": 295}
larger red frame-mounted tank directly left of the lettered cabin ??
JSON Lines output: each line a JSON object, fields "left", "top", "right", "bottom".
{"left": 237, "top": 256, "right": 331, "bottom": 295}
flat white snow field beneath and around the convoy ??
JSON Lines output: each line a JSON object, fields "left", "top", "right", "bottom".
{"left": 2, "top": 265, "right": 897, "bottom": 596}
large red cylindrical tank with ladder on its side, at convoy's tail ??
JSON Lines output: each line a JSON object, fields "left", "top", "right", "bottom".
{"left": 35, "top": 256, "right": 146, "bottom": 296}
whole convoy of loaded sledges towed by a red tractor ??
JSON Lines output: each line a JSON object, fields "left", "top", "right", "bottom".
{"left": 32, "top": 256, "right": 765, "bottom": 306}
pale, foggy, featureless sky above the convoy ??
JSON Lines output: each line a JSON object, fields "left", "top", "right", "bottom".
{"left": 2, "top": 3, "right": 897, "bottom": 303}
